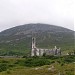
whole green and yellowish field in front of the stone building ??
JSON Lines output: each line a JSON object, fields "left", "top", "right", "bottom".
{"left": 0, "top": 55, "right": 75, "bottom": 75}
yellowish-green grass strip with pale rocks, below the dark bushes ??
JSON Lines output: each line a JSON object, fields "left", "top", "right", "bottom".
{"left": 0, "top": 64, "right": 74, "bottom": 75}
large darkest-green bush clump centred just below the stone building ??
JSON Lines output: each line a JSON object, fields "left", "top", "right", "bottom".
{"left": 24, "top": 58, "right": 50, "bottom": 67}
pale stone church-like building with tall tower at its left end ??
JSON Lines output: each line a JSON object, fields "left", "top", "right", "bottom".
{"left": 31, "top": 37, "right": 61, "bottom": 56}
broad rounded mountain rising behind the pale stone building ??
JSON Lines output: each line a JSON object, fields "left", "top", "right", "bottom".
{"left": 0, "top": 23, "right": 75, "bottom": 55}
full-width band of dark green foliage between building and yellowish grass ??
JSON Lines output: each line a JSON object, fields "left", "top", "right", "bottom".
{"left": 0, "top": 55, "right": 75, "bottom": 73}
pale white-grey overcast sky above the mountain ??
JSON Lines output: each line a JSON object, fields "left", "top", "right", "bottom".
{"left": 0, "top": 0, "right": 74, "bottom": 31}
